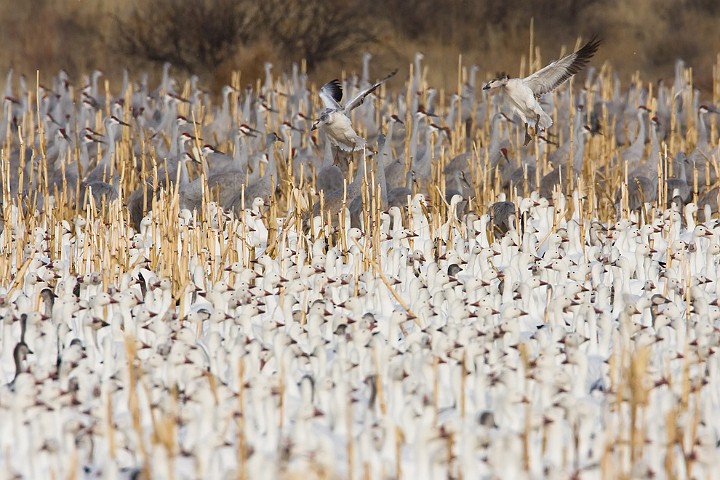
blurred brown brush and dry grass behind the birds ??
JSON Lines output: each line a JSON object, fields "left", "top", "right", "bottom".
{"left": 0, "top": 0, "right": 720, "bottom": 91}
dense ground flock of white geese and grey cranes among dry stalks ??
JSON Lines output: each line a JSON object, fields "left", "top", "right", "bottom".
{"left": 0, "top": 44, "right": 720, "bottom": 480}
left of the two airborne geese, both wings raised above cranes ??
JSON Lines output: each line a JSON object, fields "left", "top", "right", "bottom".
{"left": 311, "top": 70, "right": 397, "bottom": 152}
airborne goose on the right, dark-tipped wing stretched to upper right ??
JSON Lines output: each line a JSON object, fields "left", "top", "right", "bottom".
{"left": 483, "top": 37, "right": 600, "bottom": 145}
